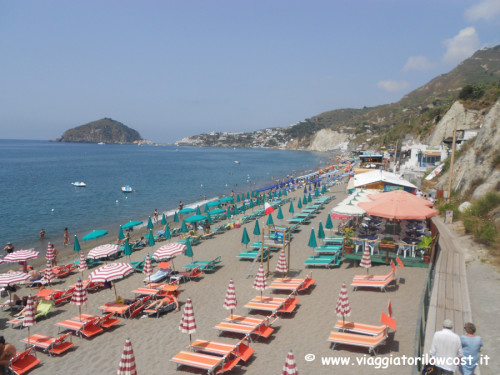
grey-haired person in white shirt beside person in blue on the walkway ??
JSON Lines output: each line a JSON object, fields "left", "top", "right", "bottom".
{"left": 429, "top": 319, "right": 463, "bottom": 375}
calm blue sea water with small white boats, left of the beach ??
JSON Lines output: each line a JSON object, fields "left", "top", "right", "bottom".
{"left": 0, "top": 140, "right": 328, "bottom": 254}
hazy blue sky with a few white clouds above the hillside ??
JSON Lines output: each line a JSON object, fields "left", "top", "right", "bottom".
{"left": 0, "top": 0, "right": 500, "bottom": 143}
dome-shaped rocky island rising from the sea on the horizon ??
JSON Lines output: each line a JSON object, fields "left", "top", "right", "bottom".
{"left": 56, "top": 118, "right": 144, "bottom": 144}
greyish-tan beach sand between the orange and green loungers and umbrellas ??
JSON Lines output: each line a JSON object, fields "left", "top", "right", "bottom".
{"left": 0, "top": 185, "right": 427, "bottom": 375}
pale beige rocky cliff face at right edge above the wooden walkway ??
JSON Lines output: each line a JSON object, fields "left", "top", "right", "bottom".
{"left": 437, "top": 100, "right": 500, "bottom": 199}
